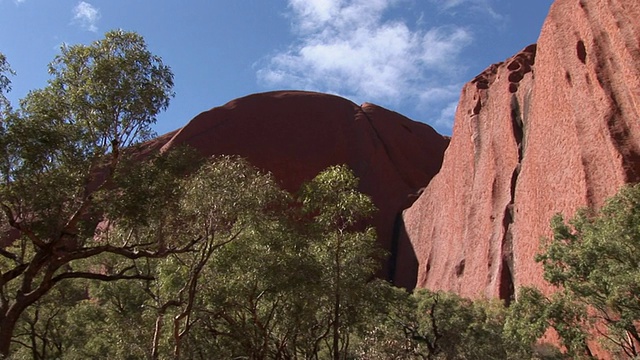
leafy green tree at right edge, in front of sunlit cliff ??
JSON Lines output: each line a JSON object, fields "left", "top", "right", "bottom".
{"left": 537, "top": 185, "right": 640, "bottom": 357}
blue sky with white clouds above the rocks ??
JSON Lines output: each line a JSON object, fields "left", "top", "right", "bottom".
{"left": 0, "top": 0, "right": 552, "bottom": 134}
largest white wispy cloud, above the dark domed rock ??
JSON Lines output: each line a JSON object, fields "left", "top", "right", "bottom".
{"left": 257, "top": 0, "right": 473, "bottom": 131}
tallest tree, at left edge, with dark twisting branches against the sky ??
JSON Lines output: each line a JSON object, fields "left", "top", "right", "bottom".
{"left": 0, "top": 31, "right": 178, "bottom": 356}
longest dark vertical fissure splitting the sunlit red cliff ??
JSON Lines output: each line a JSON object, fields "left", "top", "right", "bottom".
{"left": 498, "top": 94, "right": 524, "bottom": 306}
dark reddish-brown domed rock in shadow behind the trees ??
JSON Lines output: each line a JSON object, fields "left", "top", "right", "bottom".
{"left": 152, "top": 91, "right": 449, "bottom": 286}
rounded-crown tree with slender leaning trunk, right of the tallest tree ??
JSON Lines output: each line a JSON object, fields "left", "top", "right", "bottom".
{"left": 148, "top": 157, "right": 288, "bottom": 359}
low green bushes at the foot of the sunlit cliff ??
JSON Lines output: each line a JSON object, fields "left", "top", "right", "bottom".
{"left": 359, "top": 289, "right": 516, "bottom": 359}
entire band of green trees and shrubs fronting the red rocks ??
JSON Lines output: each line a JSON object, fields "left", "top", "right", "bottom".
{"left": 0, "top": 31, "right": 640, "bottom": 360}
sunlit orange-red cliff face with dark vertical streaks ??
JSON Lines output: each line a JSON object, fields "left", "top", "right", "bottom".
{"left": 403, "top": 0, "right": 640, "bottom": 301}
